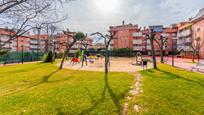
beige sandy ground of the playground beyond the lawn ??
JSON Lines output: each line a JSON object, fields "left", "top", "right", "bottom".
{"left": 58, "top": 57, "right": 152, "bottom": 72}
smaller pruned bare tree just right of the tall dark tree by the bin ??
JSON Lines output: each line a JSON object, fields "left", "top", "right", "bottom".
{"left": 154, "top": 35, "right": 168, "bottom": 63}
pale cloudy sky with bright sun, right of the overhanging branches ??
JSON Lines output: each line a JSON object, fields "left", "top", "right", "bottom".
{"left": 61, "top": 0, "right": 204, "bottom": 34}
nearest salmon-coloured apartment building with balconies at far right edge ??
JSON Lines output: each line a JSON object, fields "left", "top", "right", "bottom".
{"left": 177, "top": 8, "right": 204, "bottom": 58}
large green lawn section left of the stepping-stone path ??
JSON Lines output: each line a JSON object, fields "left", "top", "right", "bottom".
{"left": 0, "top": 63, "right": 134, "bottom": 115}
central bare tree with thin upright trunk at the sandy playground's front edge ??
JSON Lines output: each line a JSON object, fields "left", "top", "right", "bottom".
{"left": 91, "top": 31, "right": 115, "bottom": 74}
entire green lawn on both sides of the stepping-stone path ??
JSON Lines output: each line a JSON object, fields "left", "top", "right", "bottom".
{"left": 0, "top": 60, "right": 204, "bottom": 115}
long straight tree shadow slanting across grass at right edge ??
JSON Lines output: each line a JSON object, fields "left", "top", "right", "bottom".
{"left": 158, "top": 69, "right": 204, "bottom": 87}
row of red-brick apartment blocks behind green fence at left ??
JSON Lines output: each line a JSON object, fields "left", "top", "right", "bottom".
{"left": 0, "top": 28, "right": 93, "bottom": 53}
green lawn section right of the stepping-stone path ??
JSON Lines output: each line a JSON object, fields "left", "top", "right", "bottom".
{"left": 137, "top": 65, "right": 204, "bottom": 115}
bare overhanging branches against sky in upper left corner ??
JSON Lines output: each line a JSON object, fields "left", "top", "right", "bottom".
{"left": 0, "top": 0, "right": 69, "bottom": 49}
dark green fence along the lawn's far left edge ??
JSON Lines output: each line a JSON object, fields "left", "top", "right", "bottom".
{"left": 0, "top": 52, "right": 44, "bottom": 64}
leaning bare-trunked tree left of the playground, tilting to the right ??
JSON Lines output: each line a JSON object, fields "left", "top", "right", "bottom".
{"left": 59, "top": 29, "right": 87, "bottom": 69}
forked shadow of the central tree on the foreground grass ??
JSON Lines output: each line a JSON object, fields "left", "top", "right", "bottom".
{"left": 79, "top": 74, "right": 128, "bottom": 115}
